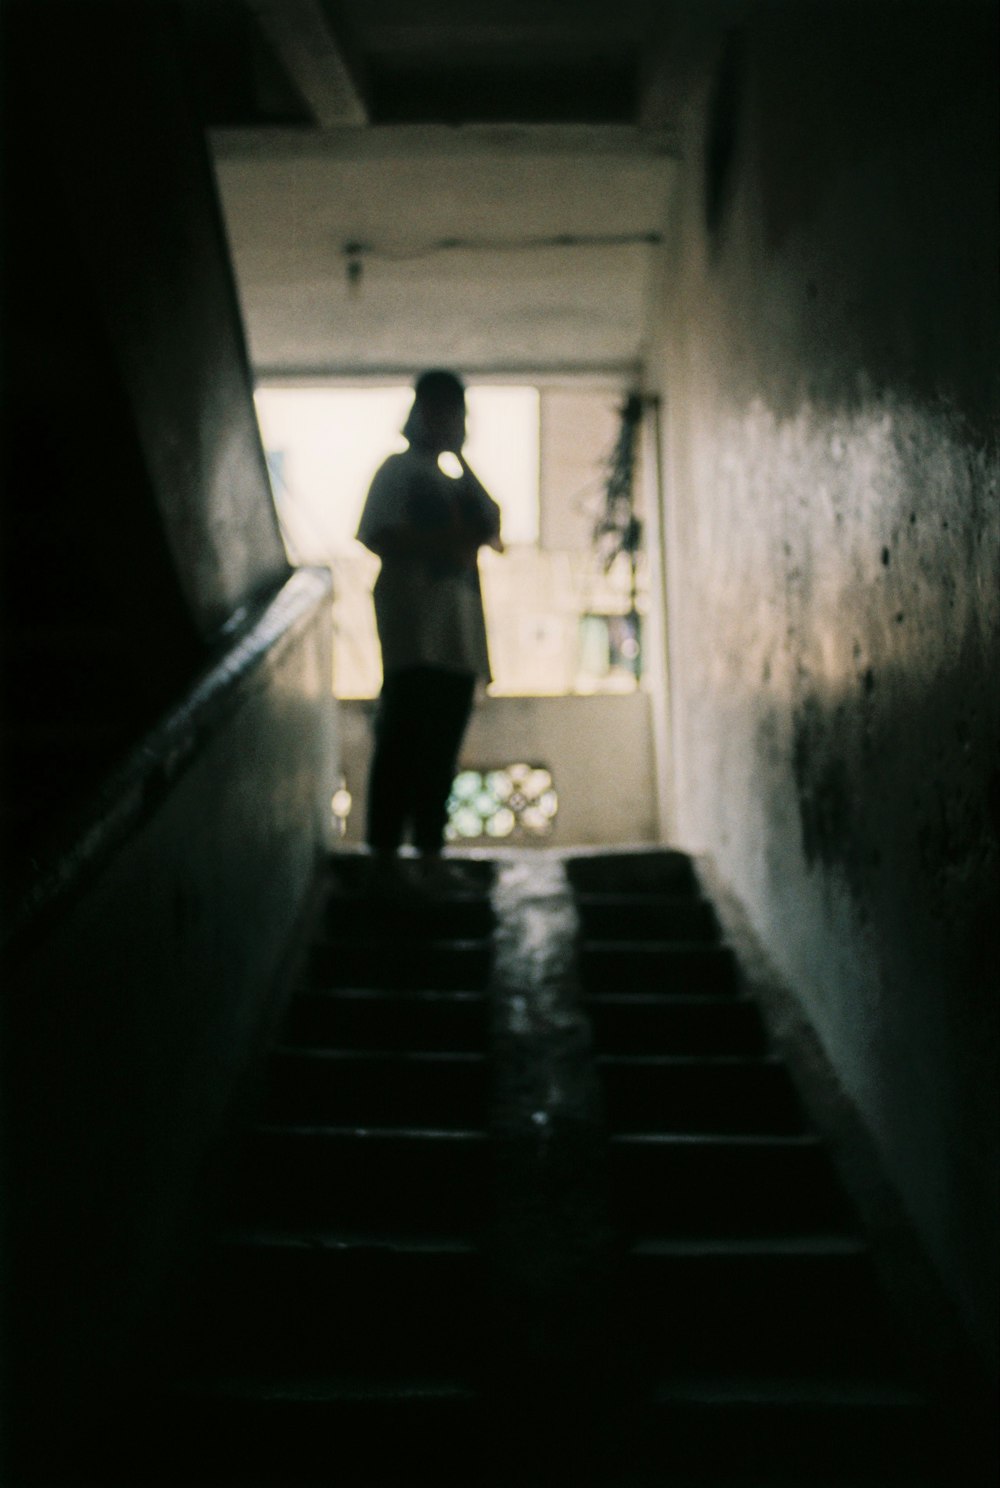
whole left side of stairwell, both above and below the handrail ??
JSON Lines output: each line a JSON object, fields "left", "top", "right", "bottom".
{"left": 0, "top": 0, "right": 335, "bottom": 1481}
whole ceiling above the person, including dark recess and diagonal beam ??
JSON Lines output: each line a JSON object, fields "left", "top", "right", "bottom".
{"left": 207, "top": 0, "right": 676, "bottom": 378}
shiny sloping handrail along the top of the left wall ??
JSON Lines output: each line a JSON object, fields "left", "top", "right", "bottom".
{"left": 0, "top": 568, "right": 333, "bottom": 952}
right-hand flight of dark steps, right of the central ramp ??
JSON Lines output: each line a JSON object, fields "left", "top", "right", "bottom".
{"left": 567, "top": 854, "right": 943, "bottom": 1488}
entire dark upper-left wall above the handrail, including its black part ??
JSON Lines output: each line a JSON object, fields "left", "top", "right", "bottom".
{"left": 0, "top": 0, "right": 289, "bottom": 863}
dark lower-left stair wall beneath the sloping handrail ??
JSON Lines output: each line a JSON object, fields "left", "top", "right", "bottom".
{"left": 1, "top": 576, "right": 333, "bottom": 1464}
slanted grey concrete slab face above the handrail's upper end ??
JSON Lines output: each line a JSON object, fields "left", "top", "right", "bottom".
{"left": 46, "top": 3, "right": 287, "bottom": 632}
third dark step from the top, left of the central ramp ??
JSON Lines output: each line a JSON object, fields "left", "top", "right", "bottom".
{"left": 307, "top": 934, "right": 493, "bottom": 991}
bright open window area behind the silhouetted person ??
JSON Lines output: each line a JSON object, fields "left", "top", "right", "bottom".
{"left": 256, "top": 384, "right": 646, "bottom": 696}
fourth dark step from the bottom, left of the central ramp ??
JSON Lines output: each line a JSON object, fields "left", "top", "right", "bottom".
{"left": 265, "top": 1049, "right": 490, "bottom": 1129}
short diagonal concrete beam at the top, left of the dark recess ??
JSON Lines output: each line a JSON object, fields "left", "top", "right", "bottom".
{"left": 246, "top": 0, "right": 368, "bottom": 129}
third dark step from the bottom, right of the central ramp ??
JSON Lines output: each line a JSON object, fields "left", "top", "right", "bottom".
{"left": 609, "top": 1134, "right": 853, "bottom": 1240}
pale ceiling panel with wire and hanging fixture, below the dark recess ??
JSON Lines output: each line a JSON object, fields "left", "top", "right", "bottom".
{"left": 216, "top": 126, "right": 671, "bottom": 375}
